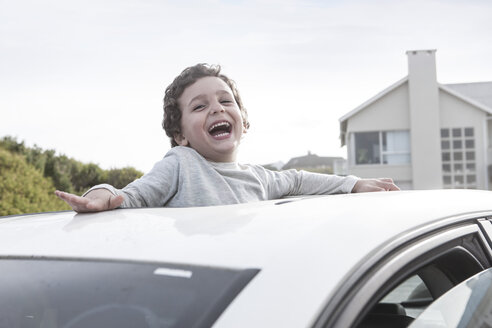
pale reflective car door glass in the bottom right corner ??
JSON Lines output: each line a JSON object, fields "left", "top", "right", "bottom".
{"left": 410, "top": 269, "right": 492, "bottom": 328}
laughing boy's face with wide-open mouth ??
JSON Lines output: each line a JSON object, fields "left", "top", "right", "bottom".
{"left": 174, "top": 77, "right": 245, "bottom": 162}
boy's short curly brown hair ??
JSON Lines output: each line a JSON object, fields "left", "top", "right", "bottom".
{"left": 162, "top": 64, "right": 249, "bottom": 147}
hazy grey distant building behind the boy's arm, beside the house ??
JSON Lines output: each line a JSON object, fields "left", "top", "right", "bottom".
{"left": 282, "top": 152, "right": 345, "bottom": 174}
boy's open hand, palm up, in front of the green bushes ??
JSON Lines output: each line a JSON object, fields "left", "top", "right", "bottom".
{"left": 55, "top": 189, "right": 124, "bottom": 213}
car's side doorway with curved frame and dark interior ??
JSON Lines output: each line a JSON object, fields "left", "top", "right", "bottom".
{"left": 314, "top": 214, "right": 492, "bottom": 328}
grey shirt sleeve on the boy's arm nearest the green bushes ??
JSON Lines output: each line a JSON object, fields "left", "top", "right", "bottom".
{"left": 83, "top": 151, "right": 179, "bottom": 208}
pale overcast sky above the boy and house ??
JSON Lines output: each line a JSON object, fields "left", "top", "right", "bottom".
{"left": 0, "top": 0, "right": 492, "bottom": 171}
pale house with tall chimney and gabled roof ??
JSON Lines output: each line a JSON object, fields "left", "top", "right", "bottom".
{"left": 340, "top": 50, "right": 492, "bottom": 189}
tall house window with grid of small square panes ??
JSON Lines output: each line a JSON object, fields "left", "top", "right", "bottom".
{"left": 441, "top": 128, "right": 477, "bottom": 189}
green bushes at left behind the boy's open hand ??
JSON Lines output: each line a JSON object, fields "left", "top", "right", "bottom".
{"left": 0, "top": 136, "right": 143, "bottom": 215}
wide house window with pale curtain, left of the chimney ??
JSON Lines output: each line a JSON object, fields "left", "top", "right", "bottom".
{"left": 354, "top": 131, "right": 410, "bottom": 165}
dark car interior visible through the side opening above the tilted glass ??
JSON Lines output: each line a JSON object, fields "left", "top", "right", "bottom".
{"left": 355, "top": 232, "right": 490, "bottom": 328}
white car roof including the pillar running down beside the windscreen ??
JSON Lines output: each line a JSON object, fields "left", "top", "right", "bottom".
{"left": 0, "top": 190, "right": 492, "bottom": 327}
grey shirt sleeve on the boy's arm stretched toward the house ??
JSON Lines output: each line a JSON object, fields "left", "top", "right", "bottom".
{"left": 256, "top": 169, "right": 359, "bottom": 199}
